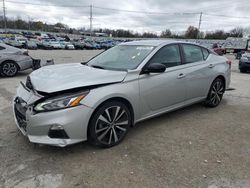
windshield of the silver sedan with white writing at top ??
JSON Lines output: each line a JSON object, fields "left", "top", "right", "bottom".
{"left": 87, "top": 45, "right": 154, "bottom": 70}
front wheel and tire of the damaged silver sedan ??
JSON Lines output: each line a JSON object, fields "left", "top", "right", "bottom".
{"left": 88, "top": 101, "right": 132, "bottom": 148}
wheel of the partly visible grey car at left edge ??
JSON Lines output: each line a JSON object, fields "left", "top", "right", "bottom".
{"left": 0, "top": 61, "right": 19, "bottom": 77}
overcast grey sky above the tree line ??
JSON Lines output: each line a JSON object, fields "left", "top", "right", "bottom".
{"left": 4, "top": 0, "right": 250, "bottom": 33}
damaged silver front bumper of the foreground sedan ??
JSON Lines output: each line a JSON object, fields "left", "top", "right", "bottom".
{"left": 13, "top": 85, "right": 93, "bottom": 147}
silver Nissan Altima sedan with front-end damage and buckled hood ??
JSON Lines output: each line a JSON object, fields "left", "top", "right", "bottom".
{"left": 13, "top": 40, "right": 231, "bottom": 147}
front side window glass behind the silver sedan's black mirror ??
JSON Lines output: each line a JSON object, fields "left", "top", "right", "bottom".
{"left": 149, "top": 44, "right": 181, "bottom": 68}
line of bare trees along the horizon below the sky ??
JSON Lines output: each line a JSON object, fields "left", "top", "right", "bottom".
{"left": 0, "top": 17, "right": 244, "bottom": 39}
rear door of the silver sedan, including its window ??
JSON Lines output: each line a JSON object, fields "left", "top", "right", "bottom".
{"left": 181, "top": 44, "right": 213, "bottom": 101}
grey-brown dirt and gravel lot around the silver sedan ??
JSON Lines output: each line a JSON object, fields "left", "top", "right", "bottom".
{"left": 0, "top": 50, "right": 250, "bottom": 188}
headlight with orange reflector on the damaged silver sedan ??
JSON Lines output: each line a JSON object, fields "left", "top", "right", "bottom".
{"left": 34, "top": 92, "right": 88, "bottom": 112}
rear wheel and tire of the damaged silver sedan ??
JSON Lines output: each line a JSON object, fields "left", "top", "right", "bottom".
{"left": 205, "top": 78, "right": 225, "bottom": 108}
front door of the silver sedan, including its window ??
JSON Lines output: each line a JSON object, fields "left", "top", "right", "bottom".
{"left": 139, "top": 44, "right": 186, "bottom": 114}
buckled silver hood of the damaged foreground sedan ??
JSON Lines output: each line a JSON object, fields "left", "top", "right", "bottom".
{"left": 30, "top": 63, "right": 127, "bottom": 93}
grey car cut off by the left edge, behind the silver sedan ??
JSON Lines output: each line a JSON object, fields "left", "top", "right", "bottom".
{"left": 0, "top": 43, "right": 33, "bottom": 77}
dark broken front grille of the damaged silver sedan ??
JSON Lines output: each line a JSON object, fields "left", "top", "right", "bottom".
{"left": 14, "top": 98, "right": 27, "bottom": 131}
